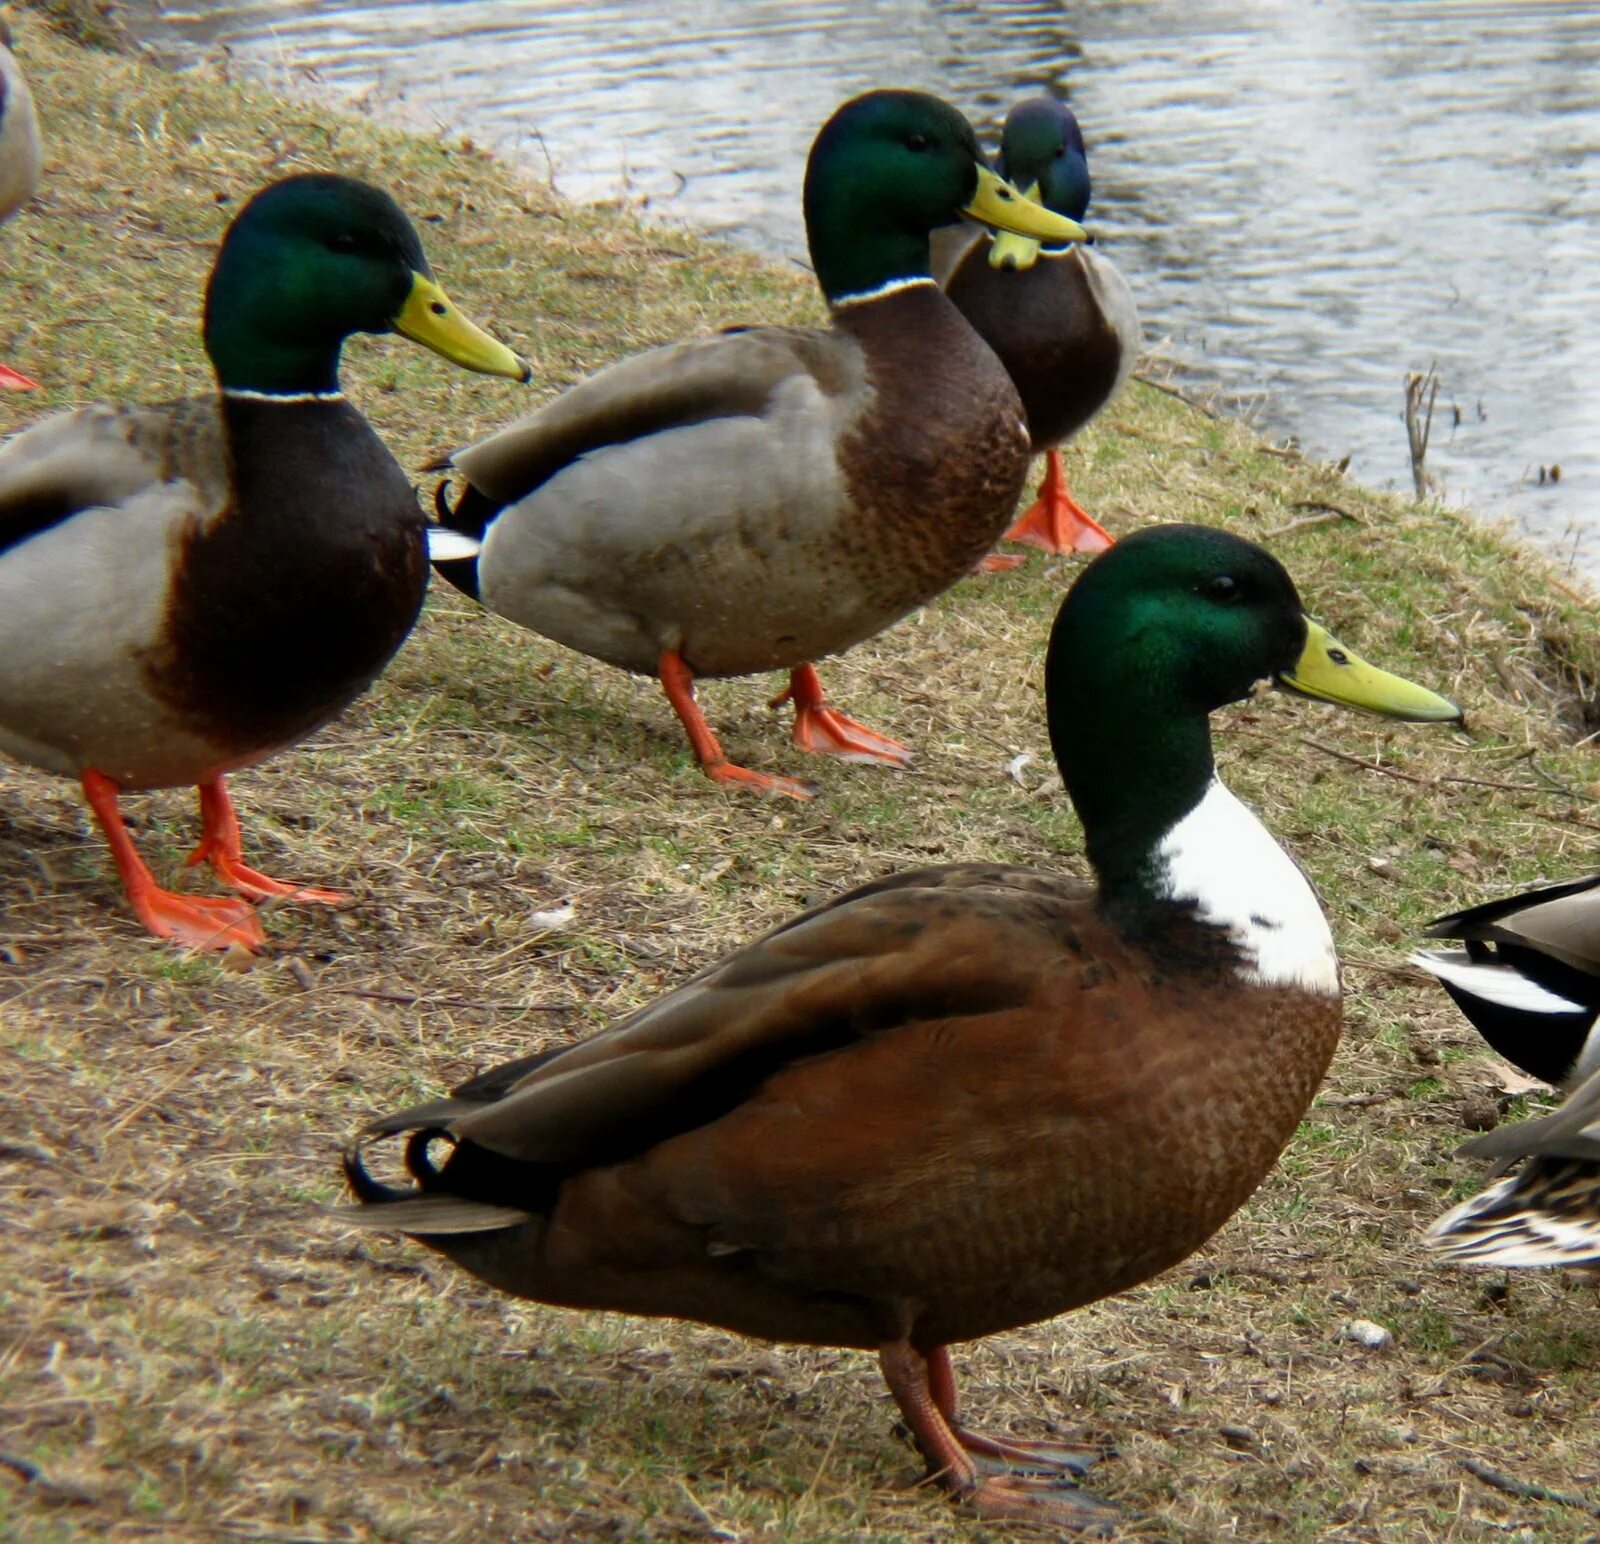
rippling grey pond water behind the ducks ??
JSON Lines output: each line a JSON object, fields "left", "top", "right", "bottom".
{"left": 134, "top": 0, "right": 1600, "bottom": 574}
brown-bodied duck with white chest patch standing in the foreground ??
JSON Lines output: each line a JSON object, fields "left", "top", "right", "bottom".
{"left": 341, "top": 526, "right": 1459, "bottom": 1526}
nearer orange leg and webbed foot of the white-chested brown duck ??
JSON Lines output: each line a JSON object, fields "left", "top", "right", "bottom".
{"left": 878, "top": 1341, "right": 1118, "bottom": 1534}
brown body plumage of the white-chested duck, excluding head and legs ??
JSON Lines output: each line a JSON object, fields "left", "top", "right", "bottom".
{"left": 347, "top": 866, "right": 1339, "bottom": 1350}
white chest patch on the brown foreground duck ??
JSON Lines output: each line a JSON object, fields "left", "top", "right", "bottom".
{"left": 1155, "top": 778, "right": 1339, "bottom": 997}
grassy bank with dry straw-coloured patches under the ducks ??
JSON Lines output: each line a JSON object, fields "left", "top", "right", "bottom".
{"left": 0, "top": 19, "right": 1600, "bottom": 1544}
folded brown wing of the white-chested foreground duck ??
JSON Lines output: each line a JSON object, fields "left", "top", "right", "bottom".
{"left": 347, "top": 864, "right": 1093, "bottom": 1190}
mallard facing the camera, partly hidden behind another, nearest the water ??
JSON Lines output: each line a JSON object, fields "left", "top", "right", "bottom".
{"left": 934, "top": 96, "right": 1139, "bottom": 566}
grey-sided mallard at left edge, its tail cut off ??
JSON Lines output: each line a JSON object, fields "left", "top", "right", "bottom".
{"left": 0, "top": 165, "right": 530, "bottom": 949}
